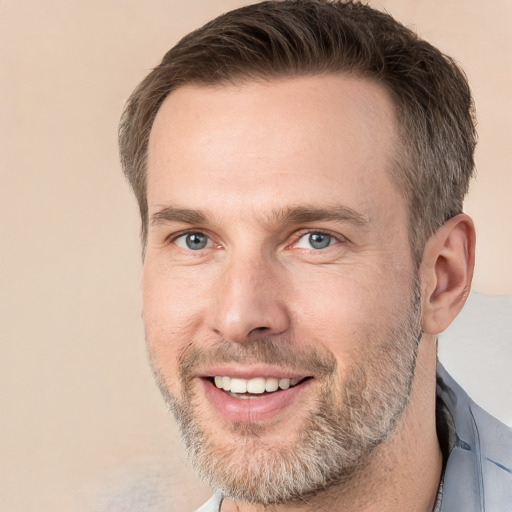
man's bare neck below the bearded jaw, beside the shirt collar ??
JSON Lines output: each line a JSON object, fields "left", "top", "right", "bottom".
{"left": 221, "top": 335, "right": 442, "bottom": 512}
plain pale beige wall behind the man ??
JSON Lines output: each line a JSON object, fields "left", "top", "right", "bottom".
{"left": 0, "top": 0, "right": 512, "bottom": 512}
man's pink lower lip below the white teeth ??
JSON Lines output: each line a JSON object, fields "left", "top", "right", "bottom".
{"left": 201, "top": 379, "right": 313, "bottom": 423}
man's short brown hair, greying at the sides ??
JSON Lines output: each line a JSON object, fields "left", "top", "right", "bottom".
{"left": 119, "top": 0, "right": 476, "bottom": 264}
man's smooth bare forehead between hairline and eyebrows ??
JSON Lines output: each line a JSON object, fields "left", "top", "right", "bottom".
{"left": 148, "top": 75, "right": 402, "bottom": 226}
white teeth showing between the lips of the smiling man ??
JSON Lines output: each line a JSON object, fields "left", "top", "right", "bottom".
{"left": 210, "top": 376, "right": 311, "bottom": 399}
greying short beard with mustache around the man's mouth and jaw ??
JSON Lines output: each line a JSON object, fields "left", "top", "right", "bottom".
{"left": 150, "top": 280, "right": 421, "bottom": 506}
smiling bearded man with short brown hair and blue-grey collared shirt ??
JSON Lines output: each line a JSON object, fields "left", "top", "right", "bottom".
{"left": 120, "top": 0, "right": 512, "bottom": 512}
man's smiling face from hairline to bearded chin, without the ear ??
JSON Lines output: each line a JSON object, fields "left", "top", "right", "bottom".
{"left": 143, "top": 76, "right": 420, "bottom": 503}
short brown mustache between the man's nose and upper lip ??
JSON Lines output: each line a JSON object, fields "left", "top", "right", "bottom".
{"left": 178, "top": 337, "right": 337, "bottom": 378}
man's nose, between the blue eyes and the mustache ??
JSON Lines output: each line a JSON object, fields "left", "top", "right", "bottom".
{"left": 209, "top": 255, "right": 290, "bottom": 343}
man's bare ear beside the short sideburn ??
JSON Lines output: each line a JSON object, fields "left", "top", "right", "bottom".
{"left": 420, "top": 213, "right": 475, "bottom": 334}
